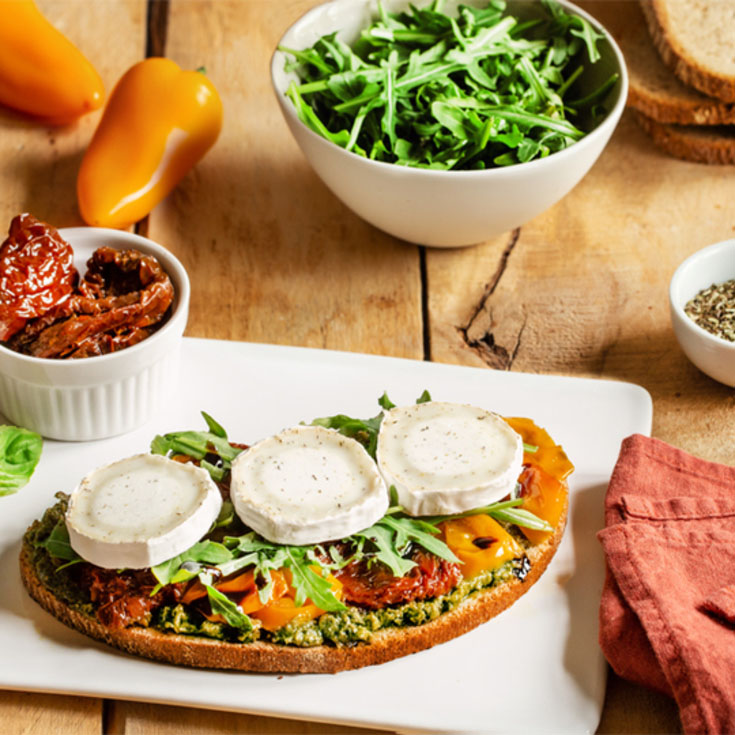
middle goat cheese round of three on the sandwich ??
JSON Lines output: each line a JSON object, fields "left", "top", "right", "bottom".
{"left": 230, "top": 426, "right": 389, "bottom": 545}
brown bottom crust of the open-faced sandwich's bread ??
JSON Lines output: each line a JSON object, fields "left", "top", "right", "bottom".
{"left": 20, "top": 499, "right": 568, "bottom": 674}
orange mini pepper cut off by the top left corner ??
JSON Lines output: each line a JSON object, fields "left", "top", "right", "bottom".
{"left": 0, "top": 0, "right": 105, "bottom": 124}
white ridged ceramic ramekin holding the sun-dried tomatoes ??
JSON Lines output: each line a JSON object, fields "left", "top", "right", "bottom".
{"left": 0, "top": 227, "right": 189, "bottom": 441}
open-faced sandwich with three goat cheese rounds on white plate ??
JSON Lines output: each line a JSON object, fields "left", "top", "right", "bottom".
{"left": 20, "top": 393, "right": 573, "bottom": 672}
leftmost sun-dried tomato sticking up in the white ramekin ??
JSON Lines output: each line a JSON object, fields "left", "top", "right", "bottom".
{"left": 0, "top": 214, "right": 78, "bottom": 341}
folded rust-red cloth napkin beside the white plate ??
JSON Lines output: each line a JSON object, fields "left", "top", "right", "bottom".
{"left": 598, "top": 434, "right": 735, "bottom": 733}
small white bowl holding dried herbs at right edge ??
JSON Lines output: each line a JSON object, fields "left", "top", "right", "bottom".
{"left": 669, "top": 240, "right": 735, "bottom": 386}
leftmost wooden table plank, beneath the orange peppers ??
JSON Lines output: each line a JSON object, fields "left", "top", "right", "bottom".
{"left": 0, "top": 0, "right": 146, "bottom": 735}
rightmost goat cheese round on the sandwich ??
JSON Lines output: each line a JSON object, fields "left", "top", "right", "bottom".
{"left": 377, "top": 401, "right": 523, "bottom": 516}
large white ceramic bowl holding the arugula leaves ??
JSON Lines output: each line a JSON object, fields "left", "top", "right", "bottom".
{"left": 271, "top": 0, "right": 628, "bottom": 247}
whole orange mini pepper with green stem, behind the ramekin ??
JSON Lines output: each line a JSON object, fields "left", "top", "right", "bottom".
{"left": 77, "top": 58, "right": 222, "bottom": 228}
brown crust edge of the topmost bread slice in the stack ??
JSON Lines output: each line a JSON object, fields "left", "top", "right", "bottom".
{"left": 641, "top": 0, "right": 735, "bottom": 102}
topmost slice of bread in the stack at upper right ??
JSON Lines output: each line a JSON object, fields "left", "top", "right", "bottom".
{"left": 641, "top": 0, "right": 735, "bottom": 102}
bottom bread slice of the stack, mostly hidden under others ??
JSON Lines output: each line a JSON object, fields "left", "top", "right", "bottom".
{"left": 636, "top": 113, "right": 735, "bottom": 164}
